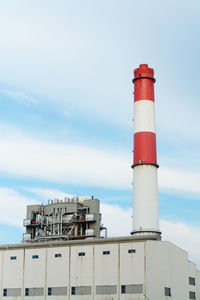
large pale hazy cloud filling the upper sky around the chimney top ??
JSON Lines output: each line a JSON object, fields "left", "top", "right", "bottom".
{"left": 0, "top": 1, "right": 199, "bottom": 135}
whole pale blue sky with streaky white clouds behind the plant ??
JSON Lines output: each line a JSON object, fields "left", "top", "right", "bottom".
{"left": 0, "top": 0, "right": 200, "bottom": 267}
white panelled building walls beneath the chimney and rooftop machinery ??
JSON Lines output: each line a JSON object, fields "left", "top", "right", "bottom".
{"left": 0, "top": 240, "right": 200, "bottom": 300}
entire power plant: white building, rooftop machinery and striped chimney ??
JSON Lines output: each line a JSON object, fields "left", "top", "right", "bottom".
{"left": 0, "top": 64, "right": 200, "bottom": 300}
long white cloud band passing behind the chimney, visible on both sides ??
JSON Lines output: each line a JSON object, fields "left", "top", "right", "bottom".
{"left": 0, "top": 124, "right": 200, "bottom": 196}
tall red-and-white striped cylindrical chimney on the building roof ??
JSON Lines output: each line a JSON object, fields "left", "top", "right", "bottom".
{"left": 132, "top": 64, "right": 160, "bottom": 237}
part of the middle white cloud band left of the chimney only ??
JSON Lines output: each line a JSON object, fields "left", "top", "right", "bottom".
{"left": 0, "top": 127, "right": 132, "bottom": 189}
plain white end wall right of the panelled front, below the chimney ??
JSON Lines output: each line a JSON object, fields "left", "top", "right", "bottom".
{"left": 146, "top": 241, "right": 189, "bottom": 300}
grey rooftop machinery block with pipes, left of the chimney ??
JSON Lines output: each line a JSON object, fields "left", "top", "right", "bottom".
{"left": 23, "top": 197, "right": 106, "bottom": 243}
